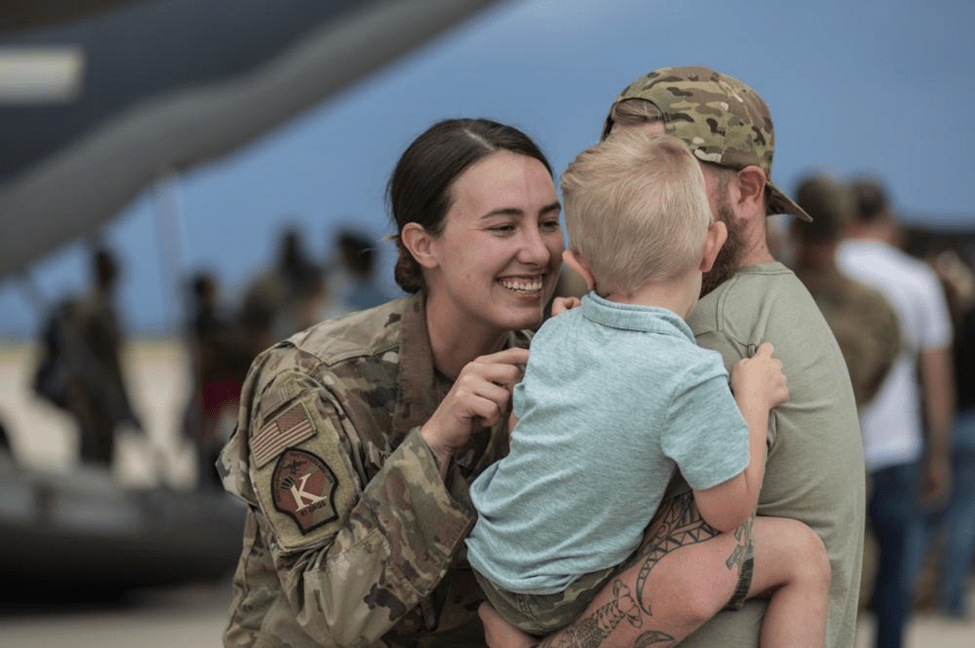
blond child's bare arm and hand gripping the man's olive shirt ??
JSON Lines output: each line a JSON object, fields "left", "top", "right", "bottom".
{"left": 694, "top": 342, "right": 789, "bottom": 531}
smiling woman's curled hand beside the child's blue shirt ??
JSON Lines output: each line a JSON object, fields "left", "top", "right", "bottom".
{"left": 420, "top": 348, "right": 528, "bottom": 474}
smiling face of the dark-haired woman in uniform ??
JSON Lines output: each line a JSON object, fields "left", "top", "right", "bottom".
{"left": 426, "top": 150, "right": 564, "bottom": 333}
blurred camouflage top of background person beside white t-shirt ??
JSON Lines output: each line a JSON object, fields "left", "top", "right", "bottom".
{"left": 796, "top": 268, "right": 901, "bottom": 407}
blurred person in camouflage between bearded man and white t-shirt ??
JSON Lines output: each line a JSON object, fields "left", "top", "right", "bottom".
{"left": 789, "top": 174, "right": 901, "bottom": 408}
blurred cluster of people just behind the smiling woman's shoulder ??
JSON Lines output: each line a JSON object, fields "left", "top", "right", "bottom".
{"left": 184, "top": 226, "right": 390, "bottom": 486}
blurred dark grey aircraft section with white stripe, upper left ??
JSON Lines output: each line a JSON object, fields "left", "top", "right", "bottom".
{"left": 0, "top": 0, "right": 498, "bottom": 280}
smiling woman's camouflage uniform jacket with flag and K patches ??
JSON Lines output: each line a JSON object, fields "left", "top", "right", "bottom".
{"left": 221, "top": 293, "right": 528, "bottom": 648}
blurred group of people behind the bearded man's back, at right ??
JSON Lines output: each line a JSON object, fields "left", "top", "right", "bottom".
{"left": 786, "top": 175, "right": 975, "bottom": 646}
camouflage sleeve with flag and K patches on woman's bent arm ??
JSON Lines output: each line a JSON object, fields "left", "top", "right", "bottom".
{"left": 247, "top": 372, "right": 474, "bottom": 646}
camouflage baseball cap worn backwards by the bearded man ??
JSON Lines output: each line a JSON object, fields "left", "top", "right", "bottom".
{"left": 603, "top": 66, "right": 812, "bottom": 221}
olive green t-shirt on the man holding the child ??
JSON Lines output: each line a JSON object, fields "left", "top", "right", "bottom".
{"left": 681, "top": 263, "right": 866, "bottom": 648}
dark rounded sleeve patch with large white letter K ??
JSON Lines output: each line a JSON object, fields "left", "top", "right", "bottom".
{"left": 271, "top": 448, "right": 338, "bottom": 534}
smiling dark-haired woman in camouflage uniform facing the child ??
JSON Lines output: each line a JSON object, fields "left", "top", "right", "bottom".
{"left": 221, "top": 120, "right": 563, "bottom": 648}
